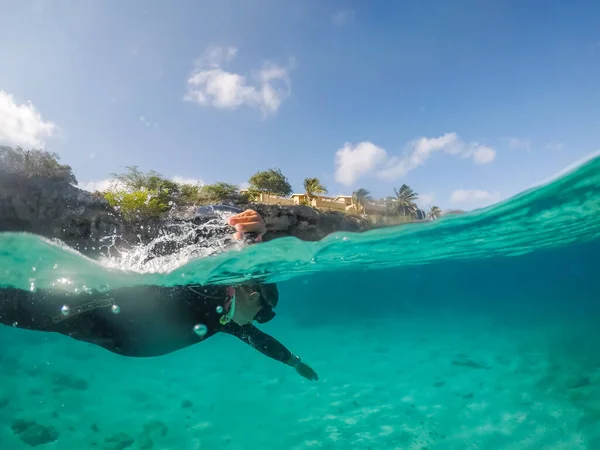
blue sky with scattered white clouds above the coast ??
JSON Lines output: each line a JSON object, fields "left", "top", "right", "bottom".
{"left": 0, "top": 0, "right": 600, "bottom": 209}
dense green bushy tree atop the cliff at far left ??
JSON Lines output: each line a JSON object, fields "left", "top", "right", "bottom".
{"left": 0, "top": 146, "right": 77, "bottom": 184}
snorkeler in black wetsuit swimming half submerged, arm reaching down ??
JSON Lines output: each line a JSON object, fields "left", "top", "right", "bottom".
{"left": 0, "top": 210, "right": 318, "bottom": 381}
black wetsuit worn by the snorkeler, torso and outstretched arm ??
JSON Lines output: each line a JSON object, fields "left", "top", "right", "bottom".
{"left": 0, "top": 286, "right": 292, "bottom": 363}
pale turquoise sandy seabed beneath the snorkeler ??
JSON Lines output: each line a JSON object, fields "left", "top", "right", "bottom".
{"left": 0, "top": 317, "right": 600, "bottom": 450}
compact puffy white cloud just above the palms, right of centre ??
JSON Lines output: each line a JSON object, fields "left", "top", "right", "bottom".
{"left": 335, "top": 142, "right": 387, "bottom": 186}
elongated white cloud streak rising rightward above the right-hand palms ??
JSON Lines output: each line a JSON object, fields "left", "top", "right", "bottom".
{"left": 378, "top": 133, "right": 496, "bottom": 179}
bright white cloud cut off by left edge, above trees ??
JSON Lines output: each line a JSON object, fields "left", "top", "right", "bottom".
{"left": 0, "top": 90, "right": 58, "bottom": 148}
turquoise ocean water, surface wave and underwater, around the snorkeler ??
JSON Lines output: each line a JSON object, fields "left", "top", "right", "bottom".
{"left": 0, "top": 158, "right": 600, "bottom": 450}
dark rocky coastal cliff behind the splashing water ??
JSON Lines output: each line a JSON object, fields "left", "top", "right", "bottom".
{"left": 0, "top": 171, "right": 372, "bottom": 257}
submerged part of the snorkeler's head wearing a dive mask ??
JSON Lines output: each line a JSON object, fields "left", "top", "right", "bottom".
{"left": 232, "top": 283, "right": 279, "bottom": 325}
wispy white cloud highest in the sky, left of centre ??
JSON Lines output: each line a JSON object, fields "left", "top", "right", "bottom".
{"left": 184, "top": 47, "right": 291, "bottom": 115}
